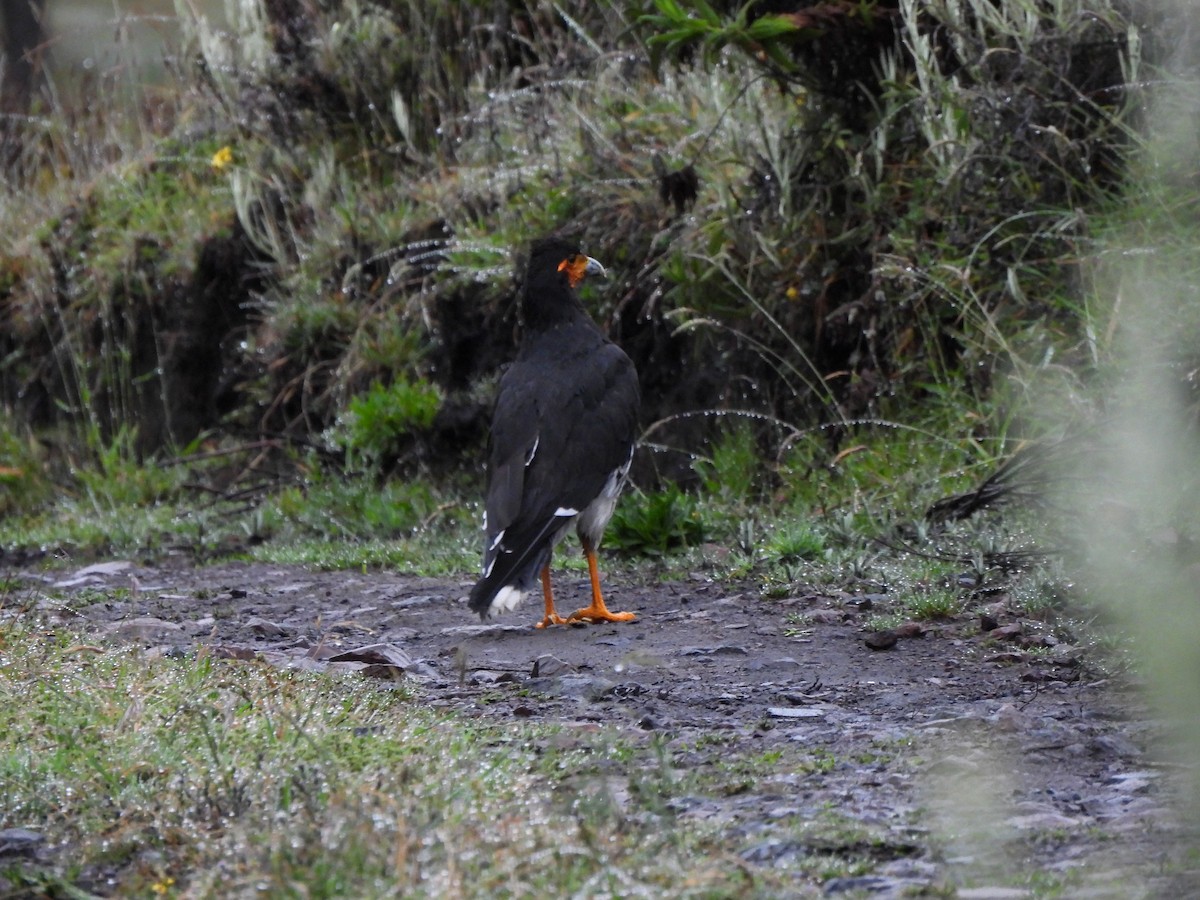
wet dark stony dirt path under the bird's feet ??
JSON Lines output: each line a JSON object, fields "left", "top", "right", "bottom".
{"left": 25, "top": 562, "right": 1200, "bottom": 900}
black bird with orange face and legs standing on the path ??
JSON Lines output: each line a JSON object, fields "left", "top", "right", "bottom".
{"left": 468, "top": 235, "right": 641, "bottom": 628}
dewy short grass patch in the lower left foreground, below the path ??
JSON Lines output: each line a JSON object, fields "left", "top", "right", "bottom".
{"left": 0, "top": 618, "right": 811, "bottom": 898}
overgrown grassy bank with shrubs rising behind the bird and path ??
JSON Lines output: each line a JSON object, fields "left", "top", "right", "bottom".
{"left": 0, "top": 0, "right": 1200, "bottom": 897}
